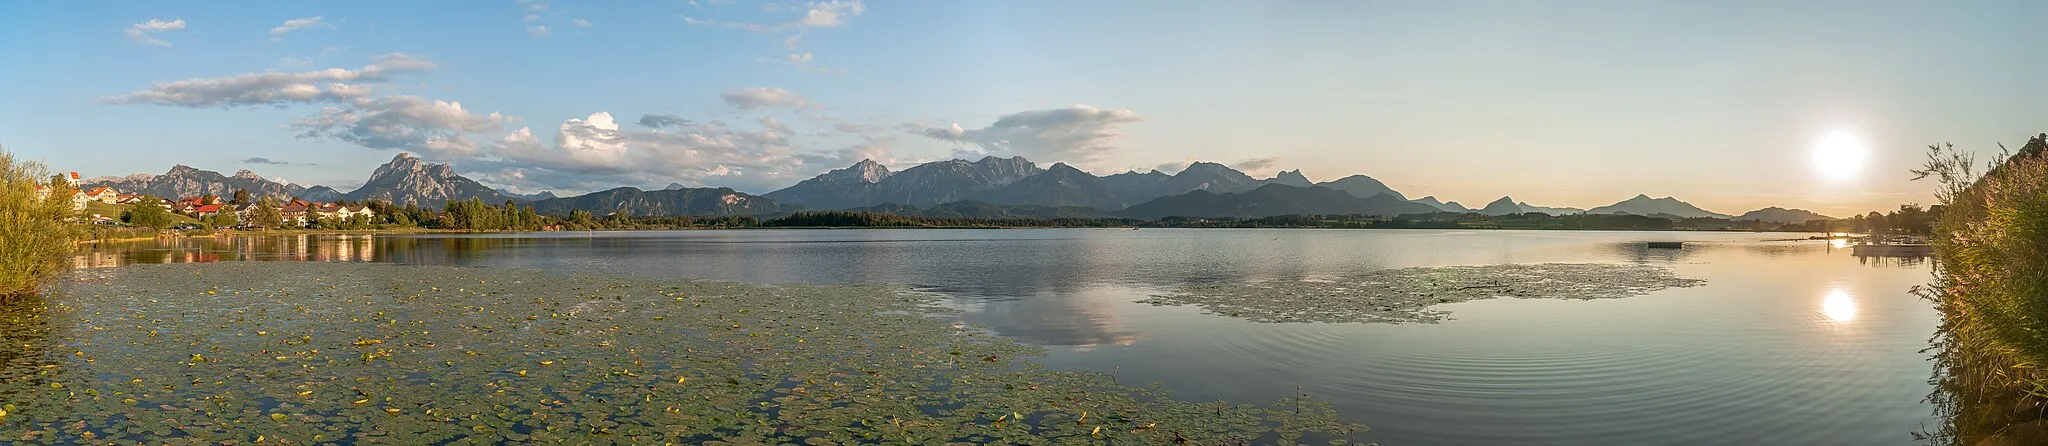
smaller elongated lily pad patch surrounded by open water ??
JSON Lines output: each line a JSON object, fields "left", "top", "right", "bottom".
{"left": 1139, "top": 264, "right": 1706, "bottom": 323}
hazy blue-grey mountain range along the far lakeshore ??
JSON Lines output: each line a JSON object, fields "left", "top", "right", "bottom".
{"left": 86, "top": 153, "right": 1827, "bottom": 223}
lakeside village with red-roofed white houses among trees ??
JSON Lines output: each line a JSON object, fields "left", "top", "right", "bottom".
{"left": 35, "top": 172, "right": 377, "bottom": 227}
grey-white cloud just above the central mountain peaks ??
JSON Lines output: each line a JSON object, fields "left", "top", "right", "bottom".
{"left": 905, "top": 104, "right": 1145, "bottom": 168}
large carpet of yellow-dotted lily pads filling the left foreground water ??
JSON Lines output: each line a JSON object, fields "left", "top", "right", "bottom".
{"left": 0, "top": 262, "right": 1364, "bottom": 444}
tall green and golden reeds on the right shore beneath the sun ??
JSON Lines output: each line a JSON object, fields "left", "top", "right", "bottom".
{"left": 1913, "top": 133, "right": 2048, "bottom": 444}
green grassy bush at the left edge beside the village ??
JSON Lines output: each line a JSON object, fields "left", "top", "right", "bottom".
{"left": 0, "top": 147, "right": 82, "bottom": 299}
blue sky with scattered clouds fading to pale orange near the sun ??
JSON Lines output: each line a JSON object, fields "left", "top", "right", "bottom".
{"left": 0, "top": 0, "right": 2048, "bottom": 217}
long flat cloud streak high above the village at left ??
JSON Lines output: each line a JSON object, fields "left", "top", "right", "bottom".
{"left": 102, "top": 53, "right": 436, "bottom": 106}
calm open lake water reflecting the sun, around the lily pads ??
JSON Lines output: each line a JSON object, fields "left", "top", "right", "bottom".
{"left": 76, "top": 229, "right": 1939, "bottom": 444}
